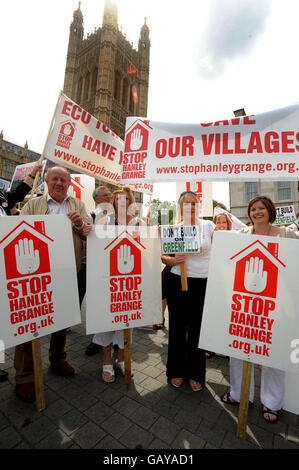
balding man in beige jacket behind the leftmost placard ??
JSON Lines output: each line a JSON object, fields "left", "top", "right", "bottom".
{"left": 14, "top": 166, "right": 89, "bottom": 402}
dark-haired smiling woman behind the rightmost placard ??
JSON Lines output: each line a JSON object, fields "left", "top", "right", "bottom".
{"left": 221, "top": 196, "right": 297, "bottom": 423}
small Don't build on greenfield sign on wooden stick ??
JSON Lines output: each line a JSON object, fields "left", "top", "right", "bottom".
{"left": 161, "top": 225, "right": 200, "bottom": 291}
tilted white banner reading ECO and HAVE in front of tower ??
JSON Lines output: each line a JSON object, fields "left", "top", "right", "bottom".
{"left": 45, "top": 94, "right": 153, "bottom": 195}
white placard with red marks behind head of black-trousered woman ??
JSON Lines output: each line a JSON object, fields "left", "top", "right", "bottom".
{"left": 176, "top": 181, "right": 213, "bottom": 217}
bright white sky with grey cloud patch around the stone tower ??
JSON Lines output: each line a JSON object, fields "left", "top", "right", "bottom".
{"left": 0, "top": 0, "right": 299, "bottom": 207}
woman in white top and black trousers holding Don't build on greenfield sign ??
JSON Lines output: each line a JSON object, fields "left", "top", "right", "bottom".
{"left": 162, "top": 191, "right": 214, "bottom": 392}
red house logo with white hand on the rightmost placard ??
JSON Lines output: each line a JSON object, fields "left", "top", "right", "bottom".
{"left": 230, "top": 240, "right": 286, "bottom": 298}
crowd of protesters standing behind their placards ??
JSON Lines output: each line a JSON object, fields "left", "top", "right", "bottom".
{"left": 0, "top": 165, "right": 299, "bottom": 423}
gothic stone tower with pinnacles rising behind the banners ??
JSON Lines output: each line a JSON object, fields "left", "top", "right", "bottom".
{"left": 64, "top": 0, "right": 150, "bottom": 138}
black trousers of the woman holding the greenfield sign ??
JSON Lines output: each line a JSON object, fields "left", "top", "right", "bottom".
{"left": 166, "top": 273, "right": 207, "bottom": 385}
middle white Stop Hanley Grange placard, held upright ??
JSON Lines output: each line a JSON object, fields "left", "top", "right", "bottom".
{"left": 86, "top": 225, "right": 162, "bottom": 334}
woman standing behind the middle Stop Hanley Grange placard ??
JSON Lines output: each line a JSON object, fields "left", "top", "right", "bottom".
{"left": 84, "top": 186, "right": 146, "bottom": 383}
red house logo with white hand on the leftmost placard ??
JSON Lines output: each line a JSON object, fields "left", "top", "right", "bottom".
{"left": 0, "top": 221, "right": 54, "bottom": 280}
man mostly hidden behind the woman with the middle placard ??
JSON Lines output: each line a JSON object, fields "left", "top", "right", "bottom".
{"left": 78, "top": 186, "right": 113, "bottom": 356}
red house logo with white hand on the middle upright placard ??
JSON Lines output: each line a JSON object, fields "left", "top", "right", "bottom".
{"left": 104, "top": 230, "right": 146, "bottom": 276}
